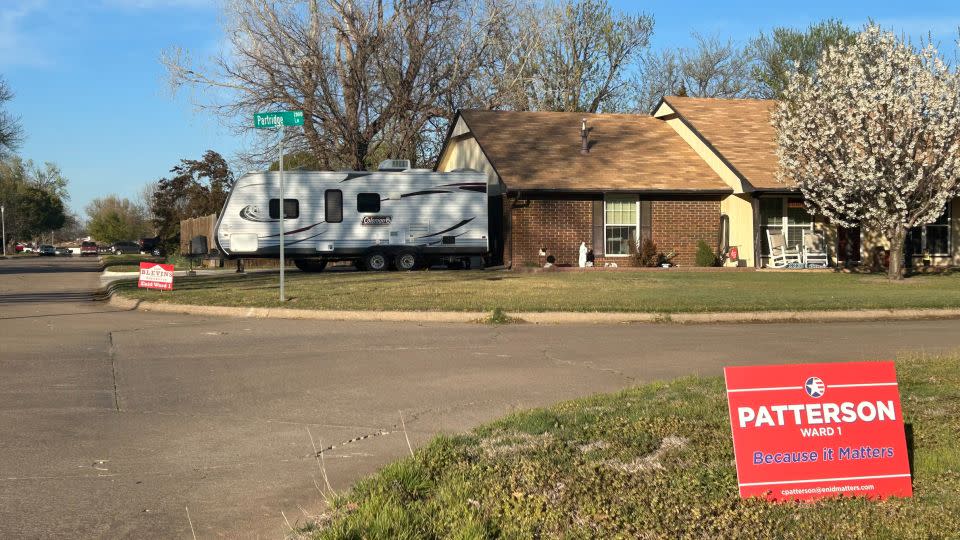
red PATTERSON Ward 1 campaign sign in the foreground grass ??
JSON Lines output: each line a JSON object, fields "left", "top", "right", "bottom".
{"left": 723, "top": 362, "right": 913, "bottom": 500}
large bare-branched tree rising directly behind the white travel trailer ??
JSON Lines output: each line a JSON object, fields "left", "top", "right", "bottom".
{"left": 162, "top": 0, "right": 524, "bottom": 169}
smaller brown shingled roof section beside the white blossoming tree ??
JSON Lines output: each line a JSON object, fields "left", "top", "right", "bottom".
{"left": 663, "top": 96, "right": 796, "bottom": 190}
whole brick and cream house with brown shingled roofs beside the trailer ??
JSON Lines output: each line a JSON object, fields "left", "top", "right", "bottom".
{"left": 436, "top": 96, "right": 960, "bottom": 267}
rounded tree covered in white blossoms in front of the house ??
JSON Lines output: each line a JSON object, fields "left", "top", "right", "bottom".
{"left": 773, "top": 25, "right": 960, "bottom": 279}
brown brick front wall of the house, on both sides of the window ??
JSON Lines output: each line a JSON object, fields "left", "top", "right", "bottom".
{"left": 504, "top": 199, "right": 720, "bottom": 268}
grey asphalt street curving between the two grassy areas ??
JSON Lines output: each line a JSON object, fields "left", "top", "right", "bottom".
{"left": 0, "top": 257, "right": 960, "bottom": 538}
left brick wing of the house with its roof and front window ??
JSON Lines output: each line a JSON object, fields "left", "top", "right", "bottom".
{"left": 436, "top": 111, "right": 733, "bottom": 267}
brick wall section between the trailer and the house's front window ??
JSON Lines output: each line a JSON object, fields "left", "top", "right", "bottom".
{"left": 505, "top": 200, "right": 593, "bottom": 268}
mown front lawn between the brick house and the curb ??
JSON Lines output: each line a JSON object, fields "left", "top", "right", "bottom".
{"left": 109, "top": 270, "right": 960, "bottom": 313}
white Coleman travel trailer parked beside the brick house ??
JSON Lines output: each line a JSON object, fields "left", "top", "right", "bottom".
{"left": 215, "top": 160, "right": 489, "bottom": 272}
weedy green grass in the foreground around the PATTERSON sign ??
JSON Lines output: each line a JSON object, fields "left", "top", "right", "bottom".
{"left": 301, "top": 356, "right": 960, "bottom": 540}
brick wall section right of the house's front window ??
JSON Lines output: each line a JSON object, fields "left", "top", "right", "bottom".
{"left": 652, "top": 200, "right": 720, "bottom": 266}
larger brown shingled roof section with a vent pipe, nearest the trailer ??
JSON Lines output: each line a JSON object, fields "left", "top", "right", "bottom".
{"left": 459, "top": 110, "right": 732, "bottom": 193}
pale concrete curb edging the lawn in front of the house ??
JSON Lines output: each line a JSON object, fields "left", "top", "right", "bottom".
{"left": 105, "top": 290, "right": 960, "bottom": 324}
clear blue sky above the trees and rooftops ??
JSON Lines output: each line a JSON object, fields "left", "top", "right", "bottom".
{"left": 0, "top": 0, "right": 960, "bottom": 212}
